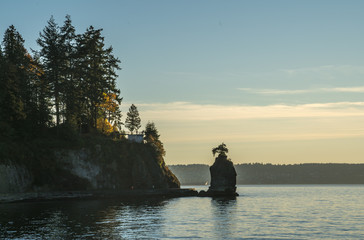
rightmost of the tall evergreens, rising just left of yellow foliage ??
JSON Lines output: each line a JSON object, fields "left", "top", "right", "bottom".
{"left": 77, "top": 26, "right": 121, "bottom": 128}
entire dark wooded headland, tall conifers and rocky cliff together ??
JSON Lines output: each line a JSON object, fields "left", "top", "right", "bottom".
{"left": 0, "top": 16, "right": 179, "bottom": 192}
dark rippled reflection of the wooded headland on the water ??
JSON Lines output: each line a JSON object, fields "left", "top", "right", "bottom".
{"left": 0, "top": 200, "right": 166, "bottom": 239}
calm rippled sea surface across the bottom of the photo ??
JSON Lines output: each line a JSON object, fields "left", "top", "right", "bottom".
{"left": 0, "top": 185, "right": 364, "bottom": 239}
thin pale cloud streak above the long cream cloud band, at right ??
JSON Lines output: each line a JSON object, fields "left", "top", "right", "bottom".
{"left": 238, "top": 86, "right": 364, "bottom": 95}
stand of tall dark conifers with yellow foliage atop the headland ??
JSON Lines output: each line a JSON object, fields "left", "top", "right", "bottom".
{"left": 0, "top": 15, "right": 123, "bottom": 137}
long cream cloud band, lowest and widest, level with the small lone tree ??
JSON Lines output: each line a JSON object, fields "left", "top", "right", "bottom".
{"left": 127, "top": 102, "right": 364, "bottom": 121}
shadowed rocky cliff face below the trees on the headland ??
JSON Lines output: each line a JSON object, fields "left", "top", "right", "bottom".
{"left": 0, "top": 136, "right": 180, "bottom": 193}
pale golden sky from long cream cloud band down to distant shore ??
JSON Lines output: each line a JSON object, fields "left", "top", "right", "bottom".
{"left": 120, "top": 102, "right": 364, "bottom": 164}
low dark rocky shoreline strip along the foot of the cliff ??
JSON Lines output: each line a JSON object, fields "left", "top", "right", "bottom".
{"left": 0, "top": 188, "right": 198, "bottom": 204}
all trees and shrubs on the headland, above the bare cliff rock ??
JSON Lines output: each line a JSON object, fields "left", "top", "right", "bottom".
{"left": 0, "top": 16, "right": 179, "bottom": 191}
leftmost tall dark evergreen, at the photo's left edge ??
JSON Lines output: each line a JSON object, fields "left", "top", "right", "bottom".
{"left": 0, "top": 26, "right": 50, "bottom": 135}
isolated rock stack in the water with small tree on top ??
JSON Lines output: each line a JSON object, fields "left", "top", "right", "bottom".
{"left": 199, "top": 143, "right": 238, "bottom": 197}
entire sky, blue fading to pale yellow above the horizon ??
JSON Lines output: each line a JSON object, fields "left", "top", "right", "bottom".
{"left": 0, "top": 0, "right": 364, "bottom": 165}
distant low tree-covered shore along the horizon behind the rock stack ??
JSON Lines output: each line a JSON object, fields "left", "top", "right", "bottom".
{"left": 169, "top": 163, "right": 364, "bottom": 185}
